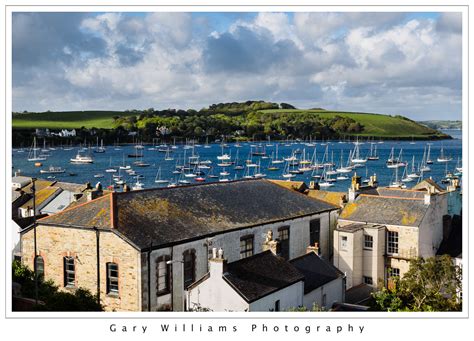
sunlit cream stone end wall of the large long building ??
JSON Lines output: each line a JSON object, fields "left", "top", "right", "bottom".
{"left": 21, "top": 225, "right": 141, "bottom": 311}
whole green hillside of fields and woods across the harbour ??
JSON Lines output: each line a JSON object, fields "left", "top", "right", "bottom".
{"left": 13, "top": 105, "right": 449, "bottom": 139}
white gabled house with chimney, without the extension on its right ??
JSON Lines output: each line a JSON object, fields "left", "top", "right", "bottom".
{"left": 188, "top": 248, "right": 304, "bottom": 311}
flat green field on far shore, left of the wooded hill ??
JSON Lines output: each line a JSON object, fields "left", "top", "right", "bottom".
{"left": 12, "top": 111, "right": 128, "bottom": 129}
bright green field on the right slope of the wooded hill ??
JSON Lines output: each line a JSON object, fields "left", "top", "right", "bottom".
{"left": 262, "top": 109, "right": 446, "bottom": 139}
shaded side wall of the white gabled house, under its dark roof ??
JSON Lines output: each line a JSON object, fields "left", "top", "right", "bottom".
{"left": 250, "top": 281, "right": 304, "bottom": 312}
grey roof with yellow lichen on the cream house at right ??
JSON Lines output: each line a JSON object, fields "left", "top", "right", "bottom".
{"left": 339, "top": 194, "right": 429, "bottom": 226}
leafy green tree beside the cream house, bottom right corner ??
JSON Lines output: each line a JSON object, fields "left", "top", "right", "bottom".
{"left": 373, "top": 255, "right": 462, "bottom": 311}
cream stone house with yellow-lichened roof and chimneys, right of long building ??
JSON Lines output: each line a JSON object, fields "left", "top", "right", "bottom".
{"left": 333, "top": 177, "right": 448, "bottom": 288}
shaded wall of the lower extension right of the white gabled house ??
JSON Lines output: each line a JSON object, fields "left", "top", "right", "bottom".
{"left": 303, "top": 277, "right": 346, "bottom": 310}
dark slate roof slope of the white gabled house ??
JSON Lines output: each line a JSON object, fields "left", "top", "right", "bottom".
{"left": 222, "top": 251, "right": 304, "bottom": 303}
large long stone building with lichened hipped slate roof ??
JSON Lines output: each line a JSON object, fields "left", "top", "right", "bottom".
{"left": 22, "top": 179, "right": 337, "bottom": 311}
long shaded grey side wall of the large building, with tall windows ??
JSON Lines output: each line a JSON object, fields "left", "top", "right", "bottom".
{"left": 146, "top": 213, "right": 330, "bottom": 311}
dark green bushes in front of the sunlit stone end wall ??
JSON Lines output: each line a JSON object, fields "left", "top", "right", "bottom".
{"left": 12, "top": 261, "right": 103, "bottom": 311}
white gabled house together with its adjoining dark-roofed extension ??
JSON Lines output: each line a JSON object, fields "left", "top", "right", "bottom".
{"left": 187, "top": 240, "right": 345, "bottom": 311}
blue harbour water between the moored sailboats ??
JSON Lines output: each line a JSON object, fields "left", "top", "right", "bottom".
{"left": 12, "top": 137, "right": 462, "bottom": 191}
